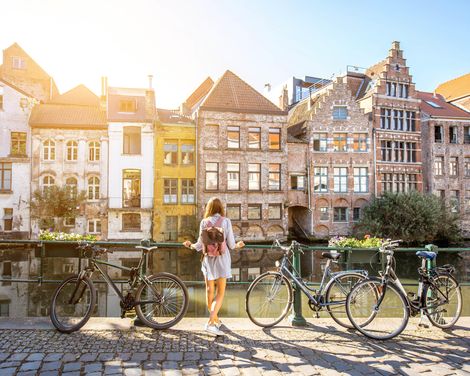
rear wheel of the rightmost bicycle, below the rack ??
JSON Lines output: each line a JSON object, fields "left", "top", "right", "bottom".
{"left": 423, "top": 274, "right": 462, "bottom": 329}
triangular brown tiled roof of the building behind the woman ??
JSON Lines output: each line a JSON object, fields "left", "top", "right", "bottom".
{"left": 201, "top": 70, "right": 287, "bottom": 115}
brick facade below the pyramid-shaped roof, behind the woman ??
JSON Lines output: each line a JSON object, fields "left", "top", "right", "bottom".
{"left": 197, "top": 110, "right": 288, "bottom": 240}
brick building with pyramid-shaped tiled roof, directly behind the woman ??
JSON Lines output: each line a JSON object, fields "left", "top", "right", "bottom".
{"left": 197, "top": 71, "right": 288, "bottom": 240}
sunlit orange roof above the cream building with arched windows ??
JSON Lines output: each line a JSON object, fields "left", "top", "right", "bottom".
{"left": 29, "top": 85, "right": 107, "bottom": 129}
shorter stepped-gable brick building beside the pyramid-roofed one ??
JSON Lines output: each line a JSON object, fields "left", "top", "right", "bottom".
{"left": 288, "top": 76, "right": 374, "bottom": 237}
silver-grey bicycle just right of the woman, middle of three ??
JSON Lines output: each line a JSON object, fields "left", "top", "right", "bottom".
{"left": 245, "top": 240, "right": 368, "bottom": 328}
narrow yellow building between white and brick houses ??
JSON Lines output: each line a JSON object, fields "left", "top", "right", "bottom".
{"left": 153, "top": 109, "right": 197, "bottom": 241}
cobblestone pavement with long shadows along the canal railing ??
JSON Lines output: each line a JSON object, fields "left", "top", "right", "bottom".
{"left": 0, "top": 320, "right": 470, "bottom": 376}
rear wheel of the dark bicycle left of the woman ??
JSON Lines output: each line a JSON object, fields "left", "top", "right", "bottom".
{"left": 135, "top": 273, "right": 189, "bottom": 329}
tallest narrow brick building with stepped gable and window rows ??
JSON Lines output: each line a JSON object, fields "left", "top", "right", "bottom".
{"left": 347, "top": 42, "right": 423, "bottom": 195}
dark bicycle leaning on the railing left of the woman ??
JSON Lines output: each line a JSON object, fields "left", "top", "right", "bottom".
{"left": 50, "top": 241, "right": 189, "bottom": 333}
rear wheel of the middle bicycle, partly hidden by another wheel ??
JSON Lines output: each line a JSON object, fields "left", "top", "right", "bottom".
{"left": 325, "top": 273, "right": 365, "bottom": 328}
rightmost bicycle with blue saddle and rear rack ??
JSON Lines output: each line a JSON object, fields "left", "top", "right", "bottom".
{"left": 346, "top": 240, "right": 462, "bottom": 340}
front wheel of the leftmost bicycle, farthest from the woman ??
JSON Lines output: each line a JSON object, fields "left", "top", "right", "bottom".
{"left": 49, "top": 275, "right": 96, "bottom": 333}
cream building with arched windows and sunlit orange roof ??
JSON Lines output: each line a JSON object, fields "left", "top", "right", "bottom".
{"left": 29, "top": 85, "right": 108, "bottom": 239}
